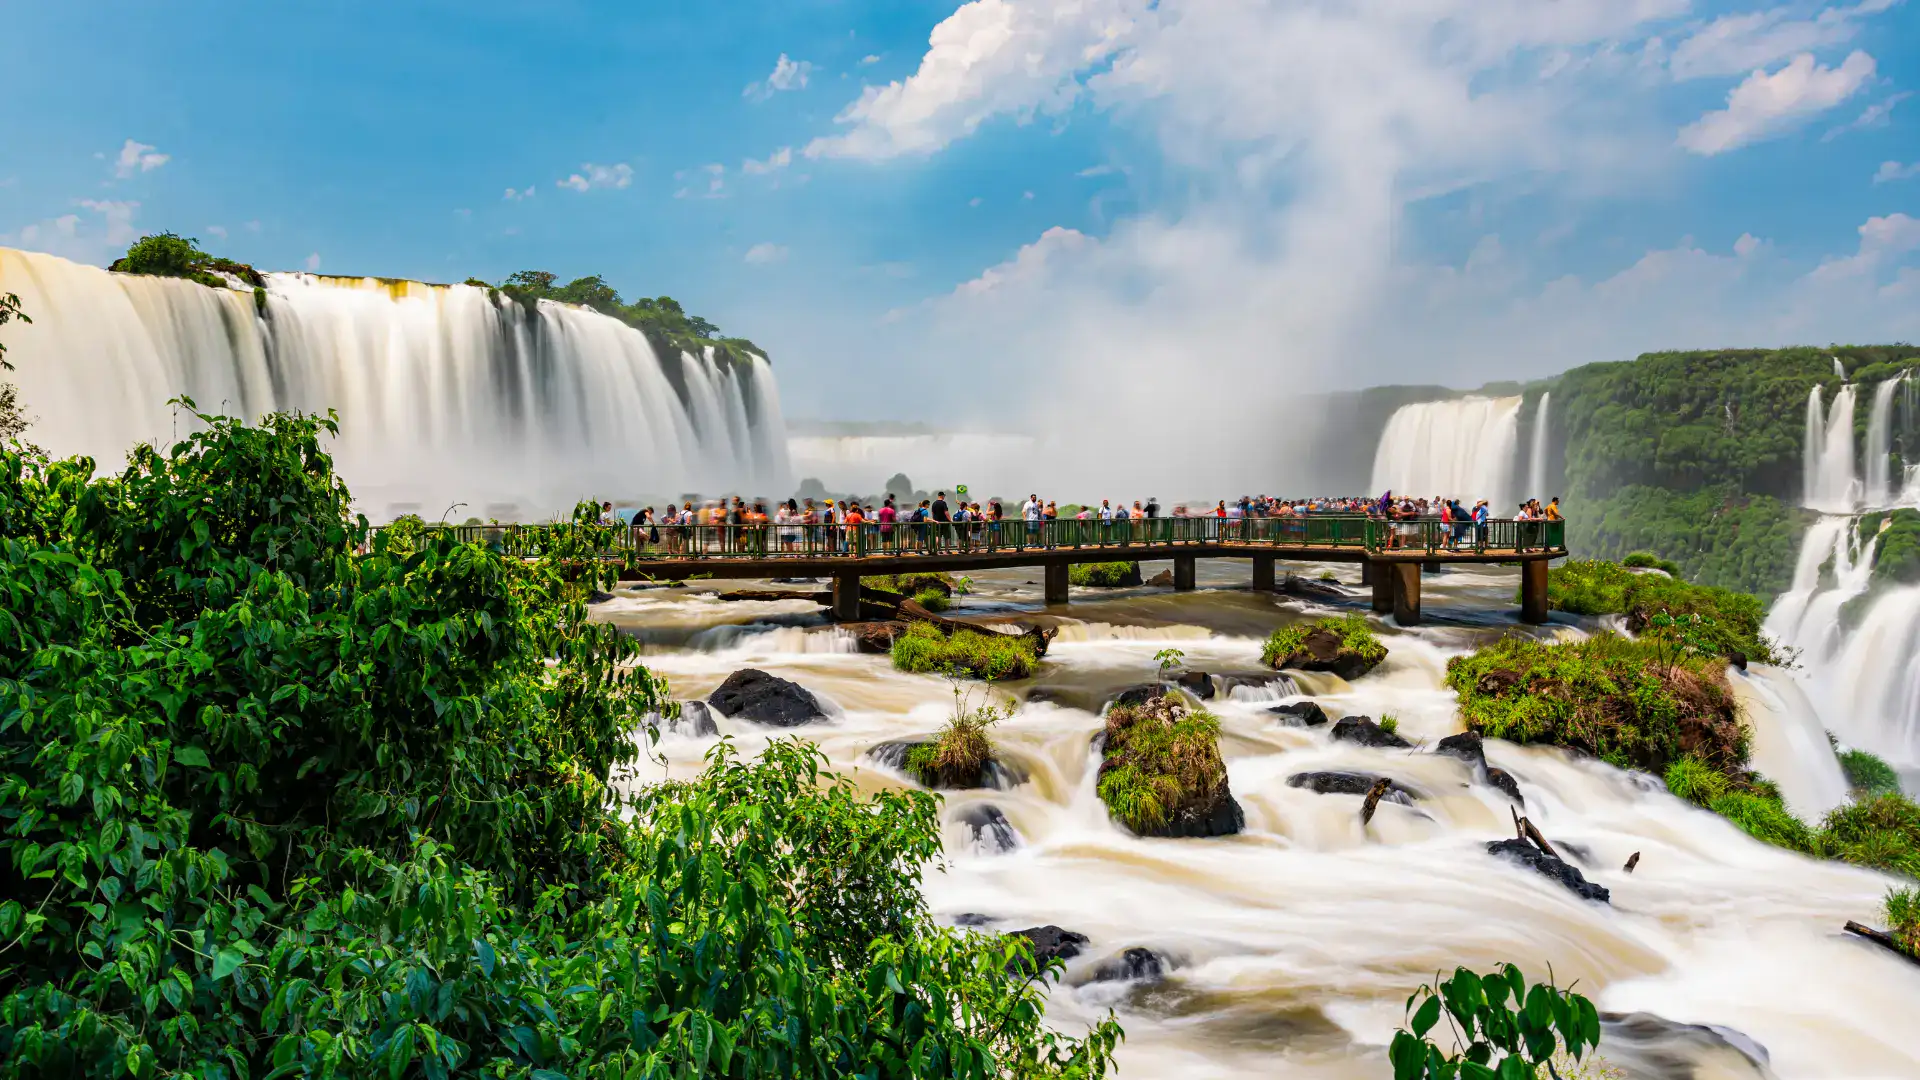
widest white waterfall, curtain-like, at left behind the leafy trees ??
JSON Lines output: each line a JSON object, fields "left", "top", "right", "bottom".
{"left": 0, "top": 248, "right": 789, "bottom": 521}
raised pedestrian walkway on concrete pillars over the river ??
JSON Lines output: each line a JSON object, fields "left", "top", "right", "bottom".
{"left": 438, "top": 515, "right": 1567, "bottom": 625}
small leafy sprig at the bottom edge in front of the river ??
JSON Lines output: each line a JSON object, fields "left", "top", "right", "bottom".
{"left": 1386, "top": 965, "right": 1599, "bottom": 1080}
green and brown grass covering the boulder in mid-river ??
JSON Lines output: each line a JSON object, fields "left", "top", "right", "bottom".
{"left": 1098, "top": 698, "right": 1227, "bottom": 836}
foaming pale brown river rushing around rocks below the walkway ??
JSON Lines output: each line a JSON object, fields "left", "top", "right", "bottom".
{"left": 599, "top": 563, "right": 1920, "bottom": 1080}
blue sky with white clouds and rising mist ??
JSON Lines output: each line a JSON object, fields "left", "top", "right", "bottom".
{"left": 0, "top": 0, "right": 1920, "bottom": 421}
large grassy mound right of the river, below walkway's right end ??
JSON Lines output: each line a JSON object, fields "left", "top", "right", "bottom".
{"left": 1446, "top": 634, "right": 1747, "bottom": 778}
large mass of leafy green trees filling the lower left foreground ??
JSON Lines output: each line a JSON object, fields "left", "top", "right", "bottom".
{"left": 0, "top": 407, "right": 1119, "bottom": 1080}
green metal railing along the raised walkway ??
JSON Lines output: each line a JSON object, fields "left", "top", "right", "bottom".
{"left": 382, "top": 515, "right": 1567, "bottom": 559}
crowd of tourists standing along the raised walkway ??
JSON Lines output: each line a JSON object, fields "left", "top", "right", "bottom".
{"left": 601, "top": 492, "right": 1561, "bottom": 552}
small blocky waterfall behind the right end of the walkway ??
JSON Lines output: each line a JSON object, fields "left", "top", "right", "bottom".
{"left": 1373, "top": 396, "right": 1521, "bottom": 517}
